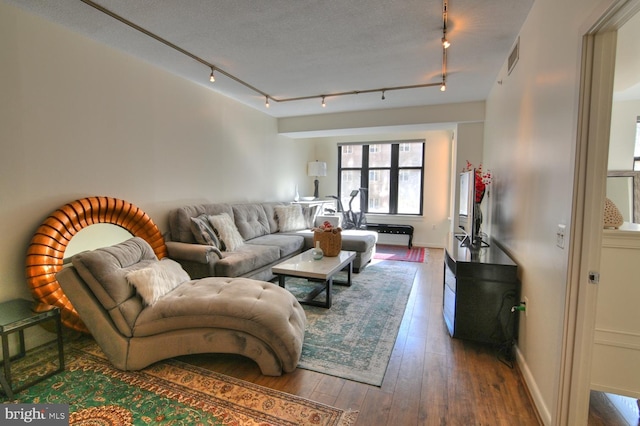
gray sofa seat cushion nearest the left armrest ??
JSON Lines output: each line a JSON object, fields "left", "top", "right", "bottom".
{"left": 215, "top": 244, "right": 280, "bottom": 277}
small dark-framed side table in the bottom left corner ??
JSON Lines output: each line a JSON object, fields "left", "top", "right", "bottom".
{"left": 0, "top": 299, "right": 64, "bottom": 399}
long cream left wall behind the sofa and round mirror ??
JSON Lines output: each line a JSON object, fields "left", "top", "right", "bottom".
{"left": 0, "top": 2, "right": 312, "bottom": 337}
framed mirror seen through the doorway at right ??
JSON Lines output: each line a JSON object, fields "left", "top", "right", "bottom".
{"left": 607, "top": 170, "right": 640, "bottom": 223}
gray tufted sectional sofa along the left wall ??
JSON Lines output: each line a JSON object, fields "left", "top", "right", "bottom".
{"left": 166, "top": 202, "right": 378, "bottom": 281}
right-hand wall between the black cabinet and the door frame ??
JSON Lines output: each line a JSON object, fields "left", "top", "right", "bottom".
{"left": 484, "top": 0, "right": 611, "bottom": 424}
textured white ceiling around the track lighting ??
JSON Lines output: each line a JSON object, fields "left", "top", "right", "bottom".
{"left": 10, "top": 0, "right": 533, "bottom": 117}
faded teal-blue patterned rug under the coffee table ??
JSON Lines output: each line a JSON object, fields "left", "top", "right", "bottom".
{"left": 286, "top": 261, "right": 416, "bottom": 386}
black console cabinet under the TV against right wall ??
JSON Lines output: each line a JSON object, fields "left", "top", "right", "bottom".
{"left": 442, "top": 237, "right": 520, "bottom": 345}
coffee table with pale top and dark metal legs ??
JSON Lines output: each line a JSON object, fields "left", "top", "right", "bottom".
{"left": 272, "top": 250, "right": 356, "bottom": 308}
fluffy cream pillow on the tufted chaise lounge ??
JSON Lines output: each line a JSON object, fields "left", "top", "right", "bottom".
{"left": 127, "top": 258, "right": 191, "bottom": 306}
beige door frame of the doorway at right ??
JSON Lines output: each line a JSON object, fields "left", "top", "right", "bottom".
{"left": 554, "top": 0, "right": 640, "bottom": 425}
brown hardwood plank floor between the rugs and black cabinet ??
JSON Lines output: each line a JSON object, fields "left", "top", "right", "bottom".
{"left": 182, "top": 249, "right": 632, "bottom": 426}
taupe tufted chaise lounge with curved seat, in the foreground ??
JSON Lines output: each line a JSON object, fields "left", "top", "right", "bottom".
{"left": 56, "top": 238, "right": 306, "bottom": 376}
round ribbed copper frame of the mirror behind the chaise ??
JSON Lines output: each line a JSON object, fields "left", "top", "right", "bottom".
{"left": 26, "top": 197, "right": 167, "bottom": 332}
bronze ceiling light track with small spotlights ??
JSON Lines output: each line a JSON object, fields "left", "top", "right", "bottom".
{"left": 80, "top": 0, "right": 451, "bottom": 108}
